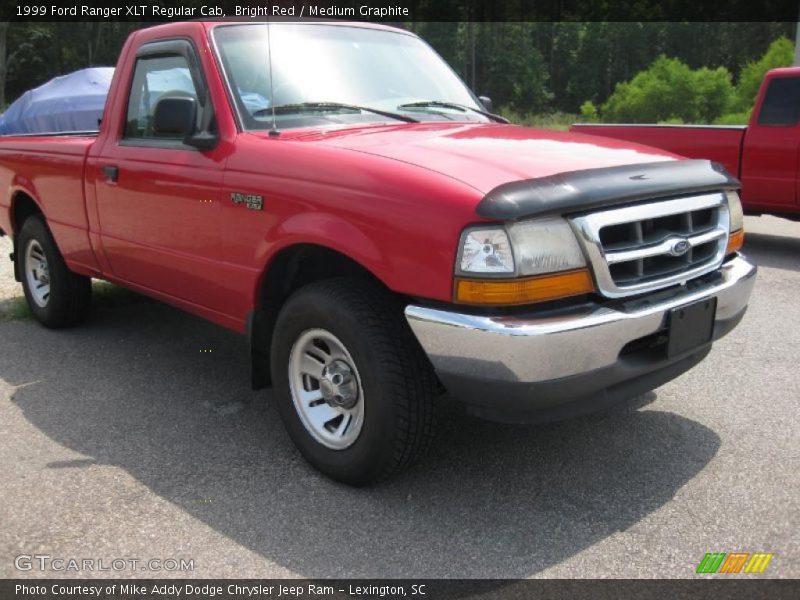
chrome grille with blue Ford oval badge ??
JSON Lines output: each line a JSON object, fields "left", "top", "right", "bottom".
{"left": 570, "top": 192, "right": 729, "bottom": 298}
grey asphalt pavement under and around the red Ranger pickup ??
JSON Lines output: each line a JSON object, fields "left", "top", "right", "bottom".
{"left": 0, "top": 217, "right": 800, "bottom": 578}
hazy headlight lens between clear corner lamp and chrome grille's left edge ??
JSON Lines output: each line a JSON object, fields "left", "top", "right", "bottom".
{"left": 509, "top": 217, "right": 586, "bottom": 275}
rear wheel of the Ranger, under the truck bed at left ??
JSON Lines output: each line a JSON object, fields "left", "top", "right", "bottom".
{"left": 16, "top": 215, "right": 92, "bottom": 329}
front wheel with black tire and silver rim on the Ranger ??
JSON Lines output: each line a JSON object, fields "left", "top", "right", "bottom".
{"left": 270, "top": 278, "right": 438, "bottom": 486}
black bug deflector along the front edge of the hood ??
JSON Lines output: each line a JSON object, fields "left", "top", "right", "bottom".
{"left": 475, "top": 160, "right": 741, "bottom": 220}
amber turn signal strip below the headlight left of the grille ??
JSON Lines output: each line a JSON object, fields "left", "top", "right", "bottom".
{"left": 455, "top": 269, "right": 594, "bottom": 305}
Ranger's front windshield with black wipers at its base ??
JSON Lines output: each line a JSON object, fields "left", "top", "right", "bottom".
{"left": 213, "top": 23, "right": 488, "bottom": 129}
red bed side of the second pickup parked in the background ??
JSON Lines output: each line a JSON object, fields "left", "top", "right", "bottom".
{"left": 570, "top": 123, "right": 747, "bottom": 177}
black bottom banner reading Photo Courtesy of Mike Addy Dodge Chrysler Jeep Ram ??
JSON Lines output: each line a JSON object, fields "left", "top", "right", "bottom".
{"left": 0, "top": 577, "right": 800, "bottom": 600}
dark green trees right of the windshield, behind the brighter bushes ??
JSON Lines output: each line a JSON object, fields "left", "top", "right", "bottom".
{"left": 416, "top": 20, "right": 794, "bottom": 121}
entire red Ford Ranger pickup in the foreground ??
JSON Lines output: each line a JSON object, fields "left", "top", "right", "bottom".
{"left": 0, "top": 22, "right": 756, "bottom": 484}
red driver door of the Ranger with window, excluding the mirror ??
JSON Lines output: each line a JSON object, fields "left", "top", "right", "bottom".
{"left": 95, "top": 39, "right": 231, "bottom": 310}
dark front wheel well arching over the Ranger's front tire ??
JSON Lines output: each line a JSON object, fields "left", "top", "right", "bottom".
{"left": 249, "top": 244, "right": 383, "bottom": 389}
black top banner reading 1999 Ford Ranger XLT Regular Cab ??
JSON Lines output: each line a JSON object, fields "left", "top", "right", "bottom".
{"left": 0, "top": 0, "right": 799, "bottom": 22}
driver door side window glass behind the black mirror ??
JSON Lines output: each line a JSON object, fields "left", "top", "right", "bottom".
{"left": 125, "top": 55, "right": 198, "bottom": 140}
